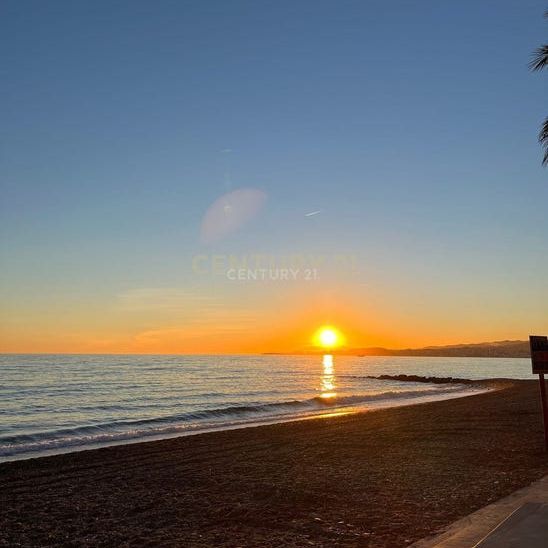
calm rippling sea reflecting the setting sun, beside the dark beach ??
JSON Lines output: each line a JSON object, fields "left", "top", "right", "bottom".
{"left": 0, "top": 354, "right": 531, "bottom": 461}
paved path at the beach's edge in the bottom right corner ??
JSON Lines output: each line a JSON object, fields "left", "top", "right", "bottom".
{"left": 413, "top": 476, "right": 548, "bottom": 548}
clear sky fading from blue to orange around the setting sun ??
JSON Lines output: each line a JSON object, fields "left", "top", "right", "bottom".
{"left": 0, "top": 0, "right": 548, "bottom": 353}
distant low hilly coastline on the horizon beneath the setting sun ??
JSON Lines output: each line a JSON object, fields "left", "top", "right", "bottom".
{"left": 265, "top": 341, "right": 530, "bottom": 358}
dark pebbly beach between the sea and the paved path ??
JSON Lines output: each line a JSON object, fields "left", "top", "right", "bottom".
{"left": 0, "top": 381, "right": 548, "bottom": 548}
